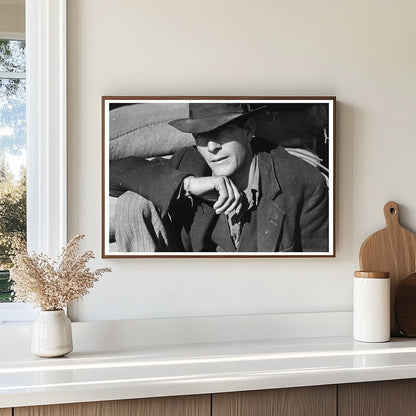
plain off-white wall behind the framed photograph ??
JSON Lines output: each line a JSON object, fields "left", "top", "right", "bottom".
{"left": 68, "top": 0, "right": 416, "bottom": 321}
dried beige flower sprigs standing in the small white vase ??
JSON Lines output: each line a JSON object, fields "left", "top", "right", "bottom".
{"left": 10, "top": 234, "right": 111, "bottom": 311}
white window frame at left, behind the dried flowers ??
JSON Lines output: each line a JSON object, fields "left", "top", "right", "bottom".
{"left": 0, "top": 0, "right": 67, "bottom": 322}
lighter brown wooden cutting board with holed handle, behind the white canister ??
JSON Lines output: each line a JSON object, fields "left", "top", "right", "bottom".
{"left": 360, "top": 201, "right": 416, "bottom": 336}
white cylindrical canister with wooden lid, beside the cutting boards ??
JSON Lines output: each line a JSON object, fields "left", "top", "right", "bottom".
{"left": 353, "top": 271, "right": 390, "bottom": 342}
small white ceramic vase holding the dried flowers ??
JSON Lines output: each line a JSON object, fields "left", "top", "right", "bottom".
{"left": 31, "top": 310, "right": 72, "bottom": 358}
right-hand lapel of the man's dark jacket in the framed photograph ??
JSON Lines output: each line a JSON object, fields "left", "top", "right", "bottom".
{"left": 257, "top": 153, "right": 286, "bottom": 252}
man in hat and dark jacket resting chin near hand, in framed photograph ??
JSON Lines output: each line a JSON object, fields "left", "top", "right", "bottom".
{"left": 110, "top": 102, "right": 329, "bottom": 253}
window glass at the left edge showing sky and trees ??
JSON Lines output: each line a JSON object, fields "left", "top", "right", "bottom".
{"left": 0, "top": 39, "right": 26, "bottom": 302}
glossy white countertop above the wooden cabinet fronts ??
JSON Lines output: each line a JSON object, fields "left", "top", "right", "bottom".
{"left": 0, "top": 337, "right": 416, "bottom": 407}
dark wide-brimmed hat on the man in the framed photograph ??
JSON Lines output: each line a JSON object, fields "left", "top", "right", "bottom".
{"left": 169, "top": 103, "right": 265, "bottom": 134}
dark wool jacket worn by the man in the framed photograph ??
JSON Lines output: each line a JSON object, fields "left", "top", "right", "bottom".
{"left": 110, "top": 147, "right": 329, "bottom": 252}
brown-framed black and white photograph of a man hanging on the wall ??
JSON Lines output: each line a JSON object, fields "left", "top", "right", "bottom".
{"left": 102, "top": 97, "right": 336, "bottom": 258}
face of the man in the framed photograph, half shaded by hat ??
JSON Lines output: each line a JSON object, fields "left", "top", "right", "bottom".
{"left": 194, "top": 118, "right": 253, "bottom": 179}
